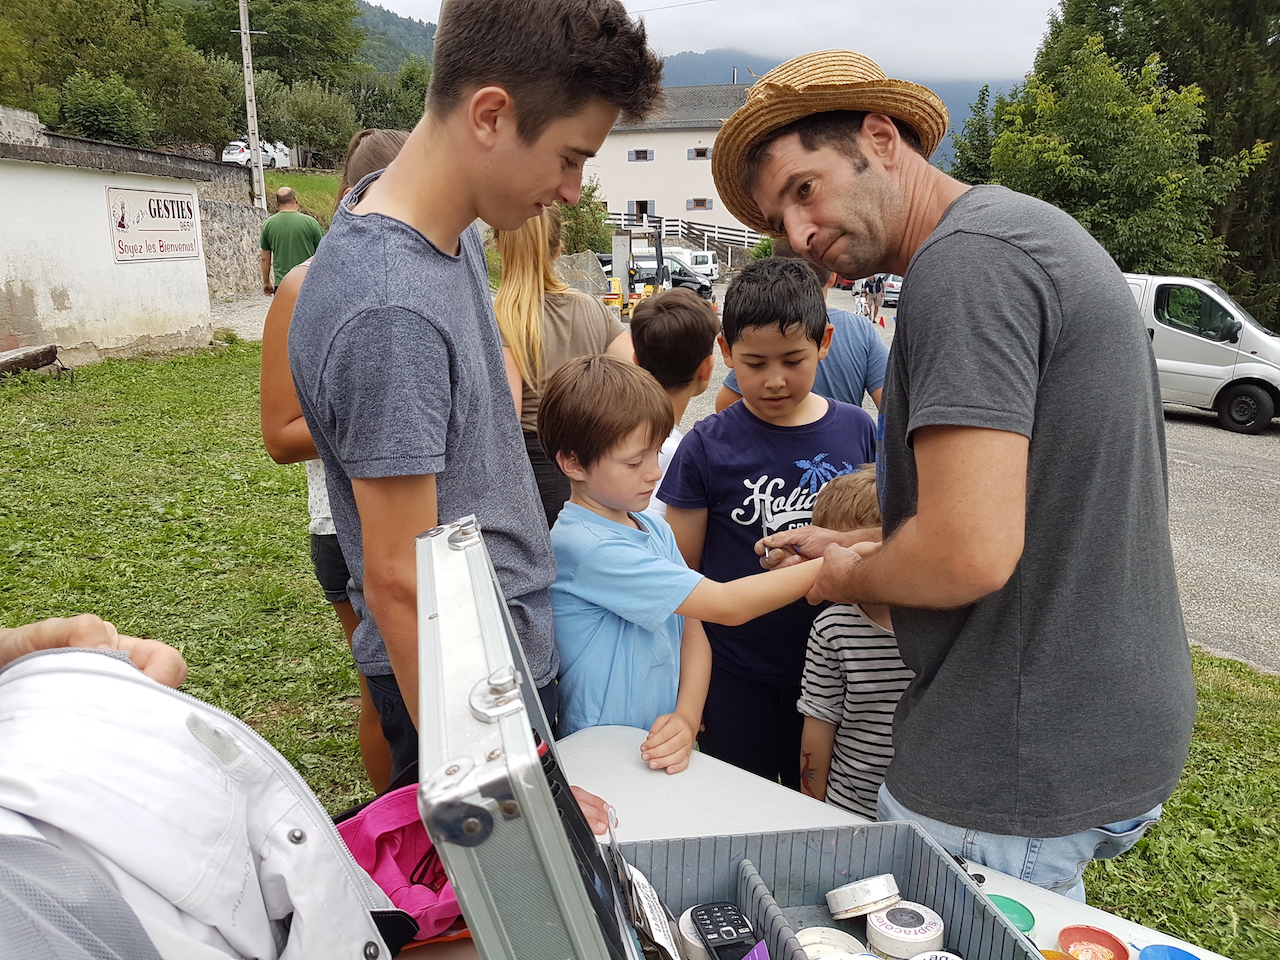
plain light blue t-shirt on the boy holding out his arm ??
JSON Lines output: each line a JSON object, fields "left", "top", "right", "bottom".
{"left": 552, "top": 503, "right": 703, "bottom": 736}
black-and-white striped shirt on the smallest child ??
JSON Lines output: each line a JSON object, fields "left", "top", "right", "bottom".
{"left": 796, "top": 604, "right": 914, "bottom": 819}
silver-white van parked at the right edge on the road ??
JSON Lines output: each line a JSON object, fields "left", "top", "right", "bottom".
{"left": 1125, "top": 274, "right": 1280, "bottom": 434}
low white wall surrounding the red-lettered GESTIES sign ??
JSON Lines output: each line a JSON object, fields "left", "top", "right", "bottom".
{"left": 0, "top": 156, "right": 211, "bottom": 364}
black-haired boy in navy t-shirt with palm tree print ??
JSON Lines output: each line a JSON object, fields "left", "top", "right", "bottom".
{"left": 658, "top": 259, "right": 876, "bottom": 788}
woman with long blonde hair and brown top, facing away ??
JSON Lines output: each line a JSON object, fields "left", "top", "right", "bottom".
{"left": 493, "top": 206, "right": 635, "bottom": 526}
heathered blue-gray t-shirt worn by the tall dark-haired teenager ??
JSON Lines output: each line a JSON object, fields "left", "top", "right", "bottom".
{"left": 289, "top": 177, "right": 558, "bottom": 686}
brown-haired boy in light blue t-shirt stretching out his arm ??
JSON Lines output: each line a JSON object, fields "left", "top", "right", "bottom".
{"left": 538, "top": 356, "right": 820, "bottom": 773}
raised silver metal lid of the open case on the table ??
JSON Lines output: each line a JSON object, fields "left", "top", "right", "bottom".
{"left": 416, "top": 517, "right": 640, "bottom": 960}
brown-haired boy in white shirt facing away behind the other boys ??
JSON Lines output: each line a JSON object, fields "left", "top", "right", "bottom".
{"left": 631, "top": 287, "right": 719, "bottom": 517}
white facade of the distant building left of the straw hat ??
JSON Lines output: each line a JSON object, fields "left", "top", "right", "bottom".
{"left": 586, "top": 128, "right": 742, "bottom": 227}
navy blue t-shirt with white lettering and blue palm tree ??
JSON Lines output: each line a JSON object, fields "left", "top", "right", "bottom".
{"left": 658, "top": 401, "right": 876, "bottom": 684}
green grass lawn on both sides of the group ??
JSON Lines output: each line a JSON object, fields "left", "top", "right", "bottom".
{"left": 0, "top": 348, "right": 1280, "bottom": 960}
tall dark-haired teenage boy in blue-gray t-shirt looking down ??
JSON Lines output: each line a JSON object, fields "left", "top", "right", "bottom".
{"left": 289, "top": 0, "right": 662, "bottom": 773}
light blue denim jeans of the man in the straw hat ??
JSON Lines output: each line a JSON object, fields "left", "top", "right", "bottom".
{"left": 876, "top": 785, "right": 1164, "bottom": 904}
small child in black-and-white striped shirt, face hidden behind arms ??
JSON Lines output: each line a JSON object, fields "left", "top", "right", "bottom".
{"left": 796, "top": 463, "right": 913, "bottom": 820}
